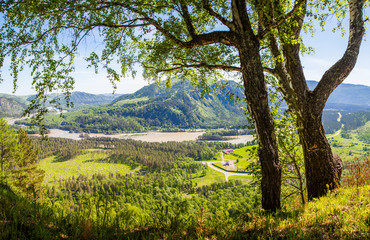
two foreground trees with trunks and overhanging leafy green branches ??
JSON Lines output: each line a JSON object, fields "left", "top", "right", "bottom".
{"left": 0, "top": 0, "right": 365, "bottom": 210}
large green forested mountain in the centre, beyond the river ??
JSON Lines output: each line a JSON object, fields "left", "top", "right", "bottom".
{"left": 45, "top": 80, "right": 247, "bottom": 133}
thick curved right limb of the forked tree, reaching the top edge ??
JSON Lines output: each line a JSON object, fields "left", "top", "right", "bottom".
{"left": 313, "top": 0, "right": 366, "bottom": 110}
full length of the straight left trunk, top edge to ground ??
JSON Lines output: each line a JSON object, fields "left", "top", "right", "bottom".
{"left": 228, "top": 0, "right": 281, "bottom": 211}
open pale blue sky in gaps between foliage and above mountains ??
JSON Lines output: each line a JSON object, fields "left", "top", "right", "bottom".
{"left": 0, "top": 14, "right": 370, "bottom": 95}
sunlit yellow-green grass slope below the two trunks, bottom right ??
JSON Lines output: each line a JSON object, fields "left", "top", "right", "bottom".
{"left": 237, "top": 185, "right": 370, "bottom": 239}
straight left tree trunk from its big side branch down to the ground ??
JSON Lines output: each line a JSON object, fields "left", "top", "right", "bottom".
{"left": 239, "top": 41, "right": 281, "bottom": 211}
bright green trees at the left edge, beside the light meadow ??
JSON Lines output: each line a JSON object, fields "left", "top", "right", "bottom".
{"left": 0, "top": 118, "right": 44, "bottom": 199}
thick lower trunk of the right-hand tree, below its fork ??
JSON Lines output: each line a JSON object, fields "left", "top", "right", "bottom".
{"left": 298, "top": 108, "right": 339, "bottom": 200}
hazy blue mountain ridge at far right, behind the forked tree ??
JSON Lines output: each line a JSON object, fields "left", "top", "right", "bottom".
{"left": 307, "top": 81, "right": 370, "bottom": 111}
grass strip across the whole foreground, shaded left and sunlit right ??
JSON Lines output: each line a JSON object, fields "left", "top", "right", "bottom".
{"left": 0, "top": 182, "right": 370, "bottom": 239}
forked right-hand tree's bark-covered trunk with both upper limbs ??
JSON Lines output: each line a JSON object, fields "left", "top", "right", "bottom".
{"left": 266, "top": 0, "right": 365, "bottom": 200}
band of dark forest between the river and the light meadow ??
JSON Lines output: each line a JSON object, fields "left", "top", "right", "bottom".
{"left": 34, "top": 137, "right": 244, "bottom": 163}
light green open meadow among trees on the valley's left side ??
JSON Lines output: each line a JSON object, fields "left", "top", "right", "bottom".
{"left": 39, "top": 151, "right": 139, "bottom": 184}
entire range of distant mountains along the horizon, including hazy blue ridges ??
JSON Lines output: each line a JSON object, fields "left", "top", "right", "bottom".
{"left": 0, "top": 81, "right": 370, "bottom": 127}
